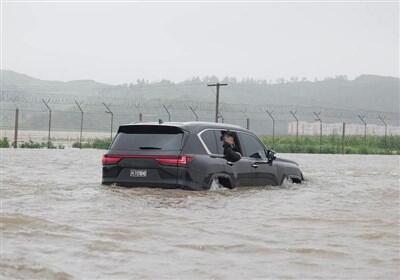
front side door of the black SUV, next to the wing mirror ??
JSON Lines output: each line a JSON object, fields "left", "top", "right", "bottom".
{"left": 239, "top": 132, "right": 276, "bottom": 186}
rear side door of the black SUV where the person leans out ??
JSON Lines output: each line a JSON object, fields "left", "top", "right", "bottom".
{"left": 215, "top": 130, "right": 254, "bottom": 186}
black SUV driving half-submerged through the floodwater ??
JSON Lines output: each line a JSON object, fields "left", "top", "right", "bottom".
{"left": 102, "top": 122, "right": 303, "bottom": 190}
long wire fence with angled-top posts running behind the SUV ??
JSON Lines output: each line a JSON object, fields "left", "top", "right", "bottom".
{"left": 0, "top": 97, "right": 400, "bottom": 151}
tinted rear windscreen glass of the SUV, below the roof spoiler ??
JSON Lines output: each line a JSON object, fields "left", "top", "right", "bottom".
{"left": 111, "top": 132, "right": 183, "bottom": 151}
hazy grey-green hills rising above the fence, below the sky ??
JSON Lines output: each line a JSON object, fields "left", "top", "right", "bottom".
{"left": 1, "top": 70, "right": 400, "bottom": 112}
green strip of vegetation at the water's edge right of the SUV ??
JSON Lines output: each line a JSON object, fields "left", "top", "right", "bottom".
{"left": 261, "top": 135, "right": 400, "bottom": 154}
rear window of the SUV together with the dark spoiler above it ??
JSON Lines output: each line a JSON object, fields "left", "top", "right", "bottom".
{"left": 111, "top": 126, "right": 183, "bottom": 151}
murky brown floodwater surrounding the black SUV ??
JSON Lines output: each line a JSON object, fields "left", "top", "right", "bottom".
{"left": 0, "top": 149, "right": 400, "bottom": 279}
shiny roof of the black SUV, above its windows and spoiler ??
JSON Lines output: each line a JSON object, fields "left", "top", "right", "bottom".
{"left": 119, "top": 121, "right": 249, "bottom": 133}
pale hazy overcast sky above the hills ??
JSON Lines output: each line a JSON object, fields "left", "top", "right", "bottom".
{"left": 2, "top": 1, "right": 399, "bottom": 84}
